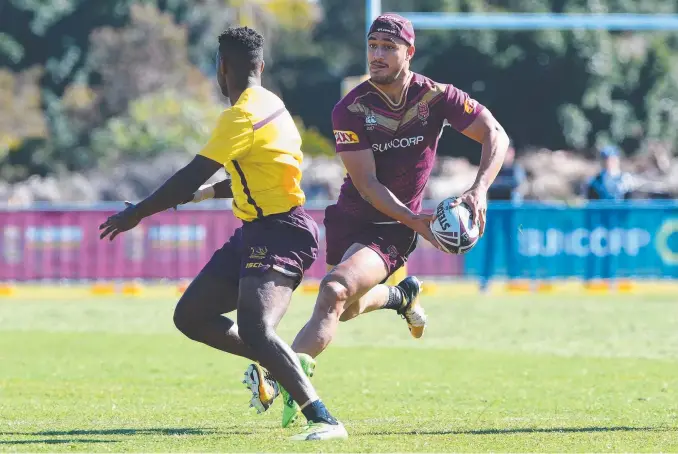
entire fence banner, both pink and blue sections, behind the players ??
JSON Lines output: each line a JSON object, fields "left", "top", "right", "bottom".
{"left": 5, "top": 202, "right": 678, "bottom": 281}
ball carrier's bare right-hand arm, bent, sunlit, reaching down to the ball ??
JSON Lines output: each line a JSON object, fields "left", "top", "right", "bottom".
{"left": 455, "top": 109, "right": 509, "bottom": 235}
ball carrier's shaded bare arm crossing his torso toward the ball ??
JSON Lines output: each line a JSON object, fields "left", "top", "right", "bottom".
{"left": 339, "top": 149, "right": 438, "bottom": 247}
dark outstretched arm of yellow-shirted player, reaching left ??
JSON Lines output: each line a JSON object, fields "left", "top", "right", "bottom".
{"left": 99, "top": 156, "right": 222, "bottom": 241}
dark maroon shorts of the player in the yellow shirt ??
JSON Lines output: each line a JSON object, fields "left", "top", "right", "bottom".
{"left": 203, "top": 207, "right": 319, "bottom": 288}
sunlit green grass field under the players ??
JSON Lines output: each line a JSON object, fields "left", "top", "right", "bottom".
{"left": 0, "top": 294, "right": 678, "bottom": 452}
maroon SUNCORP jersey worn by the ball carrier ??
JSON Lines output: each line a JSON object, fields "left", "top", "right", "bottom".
{"left": 332, "top": 73, "right": 484, "bottom": 222}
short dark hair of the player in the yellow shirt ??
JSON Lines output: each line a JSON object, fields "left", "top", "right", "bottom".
{"left": 219, "top": 27, "right": 264, "bottom": 77}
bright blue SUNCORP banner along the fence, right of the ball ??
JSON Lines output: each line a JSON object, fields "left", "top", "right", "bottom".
{"left": 465, "top": 202, "right": 678, "bottom": 279}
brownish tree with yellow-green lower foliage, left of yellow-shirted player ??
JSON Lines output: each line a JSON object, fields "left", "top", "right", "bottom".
{"left": 76, "top": 5, "right": 223, "bottom": 167}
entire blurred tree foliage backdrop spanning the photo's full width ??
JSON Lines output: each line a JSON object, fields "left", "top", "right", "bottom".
{"left": 0, "top": 0, "right": 678, "bottom": 183}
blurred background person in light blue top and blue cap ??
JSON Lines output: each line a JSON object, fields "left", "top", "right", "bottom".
{"left": 586, "top": 145, "right": 636, "bottom": 200}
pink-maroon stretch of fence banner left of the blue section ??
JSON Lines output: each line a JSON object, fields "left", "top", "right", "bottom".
{"left": 0, "top": 209, "right": 463, "bottom": 281}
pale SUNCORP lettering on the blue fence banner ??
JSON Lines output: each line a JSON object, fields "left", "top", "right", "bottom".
{"left": 519, "top": 227, "right": 651, "bottom": 257}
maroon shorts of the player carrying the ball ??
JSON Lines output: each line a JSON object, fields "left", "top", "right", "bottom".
{"left": 324, "top": 205, "right": 418, "bottom": 276}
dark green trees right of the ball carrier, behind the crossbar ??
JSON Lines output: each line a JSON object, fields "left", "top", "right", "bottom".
{"left": 415, "top": 0, "right": 678, "bottom": 152}
